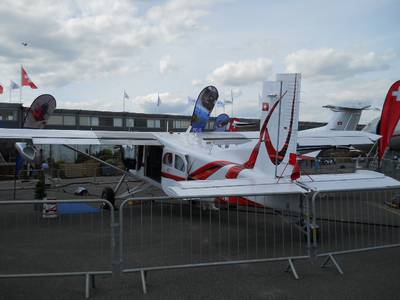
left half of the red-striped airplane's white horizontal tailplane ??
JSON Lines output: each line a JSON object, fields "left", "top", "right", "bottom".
{"left": 166, "top": 179, "right": 306, "bottom": 198}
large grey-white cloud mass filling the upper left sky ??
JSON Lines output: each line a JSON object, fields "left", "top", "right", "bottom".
{"left": 0, "top": 0, "right": 213, "bottom": 87}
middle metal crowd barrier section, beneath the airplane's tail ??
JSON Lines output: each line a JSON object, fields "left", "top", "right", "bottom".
{"left": 119, "top": 195, "right": 311, "bottom": 293}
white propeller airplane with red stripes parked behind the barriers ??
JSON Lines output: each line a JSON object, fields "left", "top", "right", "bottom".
{"left": 0, "top": 74, "right": 400, "bottom": 212}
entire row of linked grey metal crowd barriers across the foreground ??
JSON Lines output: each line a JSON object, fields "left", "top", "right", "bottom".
{"left": 0, "top": 190, "right": 400, "bottom": 297}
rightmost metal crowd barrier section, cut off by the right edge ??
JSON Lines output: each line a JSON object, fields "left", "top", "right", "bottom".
{"left": 311, "top": 189, "right": 400, "bottom": 274}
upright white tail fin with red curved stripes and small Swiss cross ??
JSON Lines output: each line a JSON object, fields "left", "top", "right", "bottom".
{"left": 249, "top": 73, "right": 301, "bottom": 177}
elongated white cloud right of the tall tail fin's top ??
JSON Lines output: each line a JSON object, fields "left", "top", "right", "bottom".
{"left": 285, "top": 48, "right": 395, "bottom": 79}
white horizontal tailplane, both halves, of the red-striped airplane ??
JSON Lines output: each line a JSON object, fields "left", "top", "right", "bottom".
{"left": 166, "top": 170, "right": 400, "bottom": 198}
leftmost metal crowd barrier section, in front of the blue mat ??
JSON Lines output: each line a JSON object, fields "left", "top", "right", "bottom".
{"left": 0, "top": 199, "right": 115, "bottom": 298}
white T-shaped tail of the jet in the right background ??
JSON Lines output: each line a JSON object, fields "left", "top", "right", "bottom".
{"left": 323, "top": 104, "right": 371, "bottom": 130}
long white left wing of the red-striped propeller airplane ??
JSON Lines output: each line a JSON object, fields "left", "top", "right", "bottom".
{"left": 0, "top": 128, "right": 161, "bottom": 145}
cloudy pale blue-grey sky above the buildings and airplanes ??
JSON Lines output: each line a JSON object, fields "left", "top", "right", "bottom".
{"left": 0, "top": 0, "right": 400, "bottom": 121}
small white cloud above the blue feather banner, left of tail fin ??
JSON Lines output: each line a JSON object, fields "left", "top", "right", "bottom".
{"left": 209, "top": 58, "right": 272, "bottom": 86}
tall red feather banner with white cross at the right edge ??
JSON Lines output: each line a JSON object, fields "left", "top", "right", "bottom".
{"left": 378, "top": 80, "right": 400, "bottom": 159}
